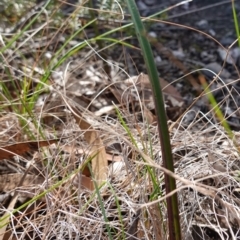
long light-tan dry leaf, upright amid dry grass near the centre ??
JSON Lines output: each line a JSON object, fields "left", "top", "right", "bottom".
{"left": 71, "top": 108, "right": 108, "bottom": 185}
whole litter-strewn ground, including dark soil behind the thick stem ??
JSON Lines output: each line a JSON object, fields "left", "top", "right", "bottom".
{"left": 0, "top": 0, "right": 240, "bottom": 240}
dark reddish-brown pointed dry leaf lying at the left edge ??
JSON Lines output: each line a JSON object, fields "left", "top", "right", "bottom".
{"left": 0, "top": 139, "right": 60, "bottom": 160}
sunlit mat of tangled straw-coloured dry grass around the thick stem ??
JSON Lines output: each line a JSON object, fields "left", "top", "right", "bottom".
{"left": 0, "top": 0, "right": 240, "bottom": 240}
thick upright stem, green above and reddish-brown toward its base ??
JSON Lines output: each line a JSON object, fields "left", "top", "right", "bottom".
{"left": 127, "top": 0, "right": 181, "bottom": 240}
